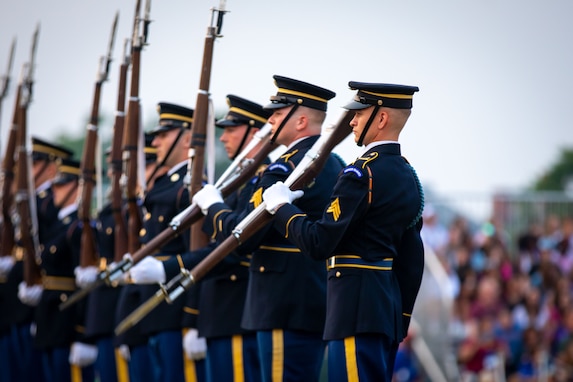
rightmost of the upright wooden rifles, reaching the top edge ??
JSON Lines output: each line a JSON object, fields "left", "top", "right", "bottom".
{"left": 186, "top": 0, "right": 227, "bottom": 250}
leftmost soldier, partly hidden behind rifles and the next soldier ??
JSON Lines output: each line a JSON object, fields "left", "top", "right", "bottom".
{"left": 0, "top": 137, "right": 73, "bottom": 381}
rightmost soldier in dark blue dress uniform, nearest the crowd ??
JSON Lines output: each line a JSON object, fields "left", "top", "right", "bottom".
{"left": 263, "top": 81, "right": 424, "bottom": 382}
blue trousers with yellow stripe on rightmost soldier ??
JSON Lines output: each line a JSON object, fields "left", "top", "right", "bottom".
{"left": 328, "top": 334, "right": 398, "bottom": 382}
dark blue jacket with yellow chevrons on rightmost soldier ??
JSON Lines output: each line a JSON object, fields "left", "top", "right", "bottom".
{"left": 275, "top": 143, "right": 424, "bottom": 341}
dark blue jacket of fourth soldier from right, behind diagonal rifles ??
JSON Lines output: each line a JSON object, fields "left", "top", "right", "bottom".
{"left": 139, "top": 166, "right": 194, "bottom": 335}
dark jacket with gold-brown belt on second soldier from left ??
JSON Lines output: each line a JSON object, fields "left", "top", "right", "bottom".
{"left": 35, "top": 211, "right": 86, "bottom": 349}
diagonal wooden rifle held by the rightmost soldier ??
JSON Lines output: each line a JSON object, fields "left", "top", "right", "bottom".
{"left": 115, "top": 111, "right": 354, "bottom": 335}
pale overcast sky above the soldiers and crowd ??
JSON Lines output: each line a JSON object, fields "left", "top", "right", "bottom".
{"left": 0, "top": 0, "right": 573, "bottom": 203}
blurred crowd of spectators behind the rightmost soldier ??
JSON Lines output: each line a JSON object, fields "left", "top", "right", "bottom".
{"left": 396, "top": 206, "right": 573, "bottom": 382}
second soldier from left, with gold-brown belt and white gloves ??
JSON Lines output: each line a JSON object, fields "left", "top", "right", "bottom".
{"left": 18, "top": 159, "right": 97, "bottom": 382}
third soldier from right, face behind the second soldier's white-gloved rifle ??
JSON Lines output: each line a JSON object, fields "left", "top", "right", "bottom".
{"left": 130, "top": 94, "right": 271, "bottom": 382}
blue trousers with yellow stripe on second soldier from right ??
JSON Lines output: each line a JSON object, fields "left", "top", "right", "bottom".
{"left": 257, "top": 329, "right": 326, "bottom": 382}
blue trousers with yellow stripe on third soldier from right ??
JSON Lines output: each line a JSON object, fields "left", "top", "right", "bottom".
{"left": 206, "top": 333, "right": 261, "bottom": 382}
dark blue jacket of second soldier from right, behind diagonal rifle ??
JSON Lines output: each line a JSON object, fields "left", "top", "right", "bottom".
{"left": 205, "top": 136, "right": 343, "bottom": 333}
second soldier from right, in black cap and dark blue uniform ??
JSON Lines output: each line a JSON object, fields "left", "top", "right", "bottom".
{"left": 193, "top": 75, "right": 343, "bottom": 381}
